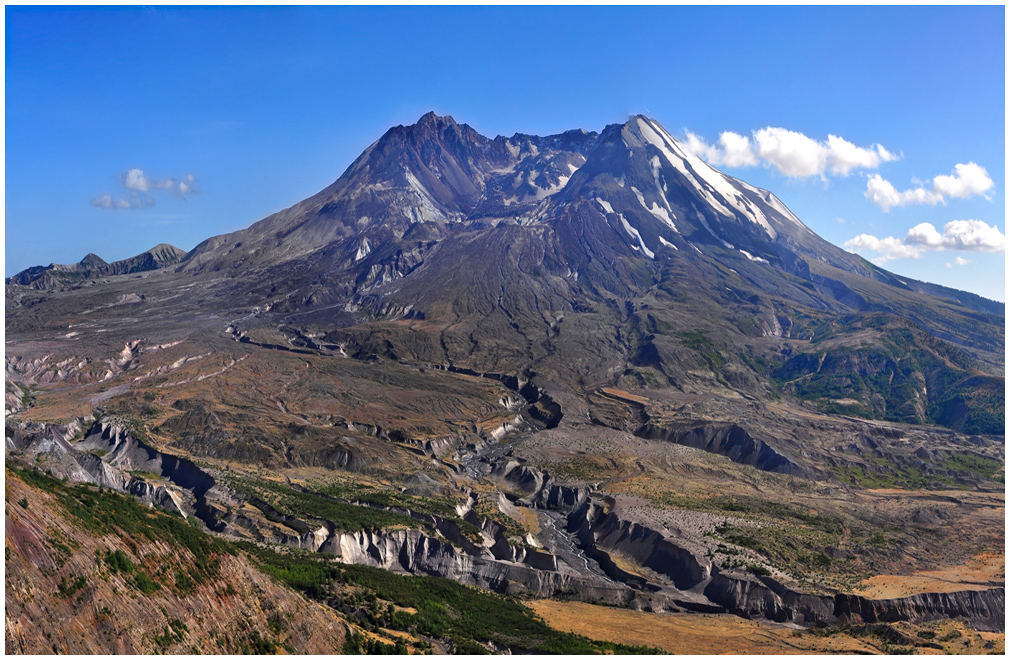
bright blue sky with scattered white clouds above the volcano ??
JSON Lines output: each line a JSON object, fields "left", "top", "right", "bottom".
{"left": 4, "top": 7, "right": 1006, "bottom": 300}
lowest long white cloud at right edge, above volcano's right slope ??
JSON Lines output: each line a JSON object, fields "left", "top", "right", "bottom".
{"left": 843, "top": 220, "right": 1007, "bottom": 266}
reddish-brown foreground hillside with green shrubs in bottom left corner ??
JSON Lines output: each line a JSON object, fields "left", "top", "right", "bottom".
{"left": 4, "top": 462, "right": 347, "bottom": 654}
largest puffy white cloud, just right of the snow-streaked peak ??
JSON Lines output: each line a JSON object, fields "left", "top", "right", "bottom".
{"left": 685, "top": 126, "right": 898, "bottom": 177}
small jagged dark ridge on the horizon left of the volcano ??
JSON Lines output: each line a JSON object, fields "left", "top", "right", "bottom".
{"left": 5, "top": 243, "right": 186, "bottom": 289}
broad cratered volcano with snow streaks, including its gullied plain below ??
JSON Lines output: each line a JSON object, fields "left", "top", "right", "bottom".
{"left": 5, "top": 113, "right": 1005, "bottom": 646}
